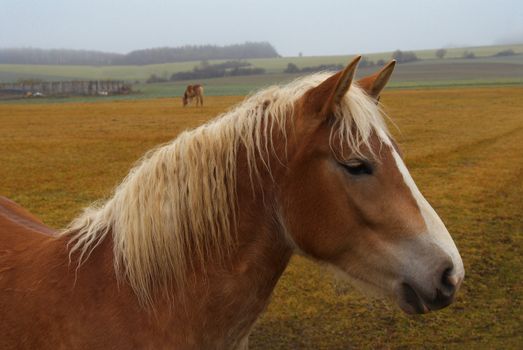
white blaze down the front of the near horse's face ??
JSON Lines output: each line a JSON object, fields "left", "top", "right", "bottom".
{"left": 391, "top": 147, "right": 465, "bottom": 282}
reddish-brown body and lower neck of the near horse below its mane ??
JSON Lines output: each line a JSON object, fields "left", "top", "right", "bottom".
{"left": 0, "top": 194, "right": 291, "bottom": 349}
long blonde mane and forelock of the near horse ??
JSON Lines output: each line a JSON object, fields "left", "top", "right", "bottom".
{"left": 62, "top": 73, "right": 387, "bottom": 304}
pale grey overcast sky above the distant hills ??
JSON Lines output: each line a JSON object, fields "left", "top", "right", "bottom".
{"left": 0, "top": 0, "right": 523, "bottom": 56}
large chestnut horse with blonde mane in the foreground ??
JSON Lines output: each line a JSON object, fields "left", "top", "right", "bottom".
{"left": 0, "top": 56, "right": 464, "bottom": 349}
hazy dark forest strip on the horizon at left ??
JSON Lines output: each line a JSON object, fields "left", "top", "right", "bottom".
{"left": 0, "top": 42, "right": 280, "bottom": 65}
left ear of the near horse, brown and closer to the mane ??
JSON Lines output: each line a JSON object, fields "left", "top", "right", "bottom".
{"left": 305, "top": 56, "right": 361, "bottom": 116}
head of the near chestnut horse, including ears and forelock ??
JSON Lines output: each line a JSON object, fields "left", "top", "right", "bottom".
{"left": 280, "top": 57, "right": 464, "bottom": 313}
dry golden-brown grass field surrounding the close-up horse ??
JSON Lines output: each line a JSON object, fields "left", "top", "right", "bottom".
{"left": 0, "top": 87, "right": 523, "bottom": 349}
